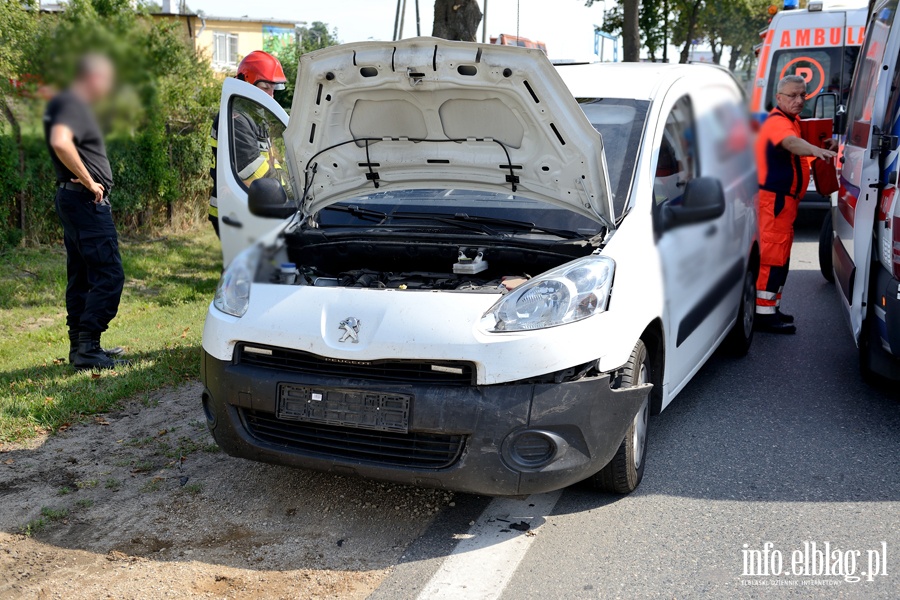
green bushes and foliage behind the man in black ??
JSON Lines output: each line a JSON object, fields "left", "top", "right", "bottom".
{"left": 0, "top": 0, "right": 219, "bottom": 243}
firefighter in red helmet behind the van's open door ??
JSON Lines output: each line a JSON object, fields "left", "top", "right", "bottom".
{"left": 209, "top": 50, "right": 287, "bottom": 236}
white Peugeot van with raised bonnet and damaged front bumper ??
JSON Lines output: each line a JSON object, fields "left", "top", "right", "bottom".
{"left": 202, "top": 38, "right": 759, "bottom": 495}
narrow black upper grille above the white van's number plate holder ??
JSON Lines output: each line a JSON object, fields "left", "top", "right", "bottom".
{"left": 237, "top": 344, "right": 475, "bottom": 385}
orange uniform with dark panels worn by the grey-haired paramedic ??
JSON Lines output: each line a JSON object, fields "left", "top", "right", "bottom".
{"left": 756, "top": 107, "right": 809, "bottom": 315}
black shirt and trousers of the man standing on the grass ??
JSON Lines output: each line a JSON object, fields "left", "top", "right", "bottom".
{"left": 44, "top": 91, "right": 125, "bottom": 341}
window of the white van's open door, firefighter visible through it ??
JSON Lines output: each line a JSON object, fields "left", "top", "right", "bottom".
{"left": 228, "top": 97, "right": 294, "bottom": 199}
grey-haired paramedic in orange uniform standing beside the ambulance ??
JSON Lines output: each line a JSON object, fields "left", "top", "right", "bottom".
{"left": 754, "top": 75, "right": 837, "bottom": 334}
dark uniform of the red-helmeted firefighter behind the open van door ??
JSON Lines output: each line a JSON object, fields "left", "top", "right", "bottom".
{"left": 209, "top": 110, "right": 281, "bottom": 235}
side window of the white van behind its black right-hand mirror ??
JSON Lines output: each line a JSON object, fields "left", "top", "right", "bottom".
{"left": 653, "top": 96, "right": 698, "bottom": 205}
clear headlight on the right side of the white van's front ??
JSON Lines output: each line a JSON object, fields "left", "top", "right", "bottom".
{"left": 482, "top": 256, "right": 616, "bottom": 332}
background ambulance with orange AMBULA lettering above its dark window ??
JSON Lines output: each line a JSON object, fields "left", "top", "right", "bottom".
{"left": 750, "top": 0, "right": 868, "bottom": 123}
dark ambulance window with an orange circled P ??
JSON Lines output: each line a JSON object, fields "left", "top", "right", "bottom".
{"left": 766, "top": 46, "right": 859, "bottom": 118}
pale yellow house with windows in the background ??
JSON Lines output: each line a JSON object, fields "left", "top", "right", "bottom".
{"left": 151, "top": 12, "right": 297, "bottom": 73}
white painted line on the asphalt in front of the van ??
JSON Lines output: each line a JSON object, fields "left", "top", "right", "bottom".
{"left": 419, "top": 491, "right": 562, "bottom": 600}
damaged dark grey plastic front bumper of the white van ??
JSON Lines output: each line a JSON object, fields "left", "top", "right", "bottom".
{"left": 202, "top": 350, "right": 652, "bottom": 496}
